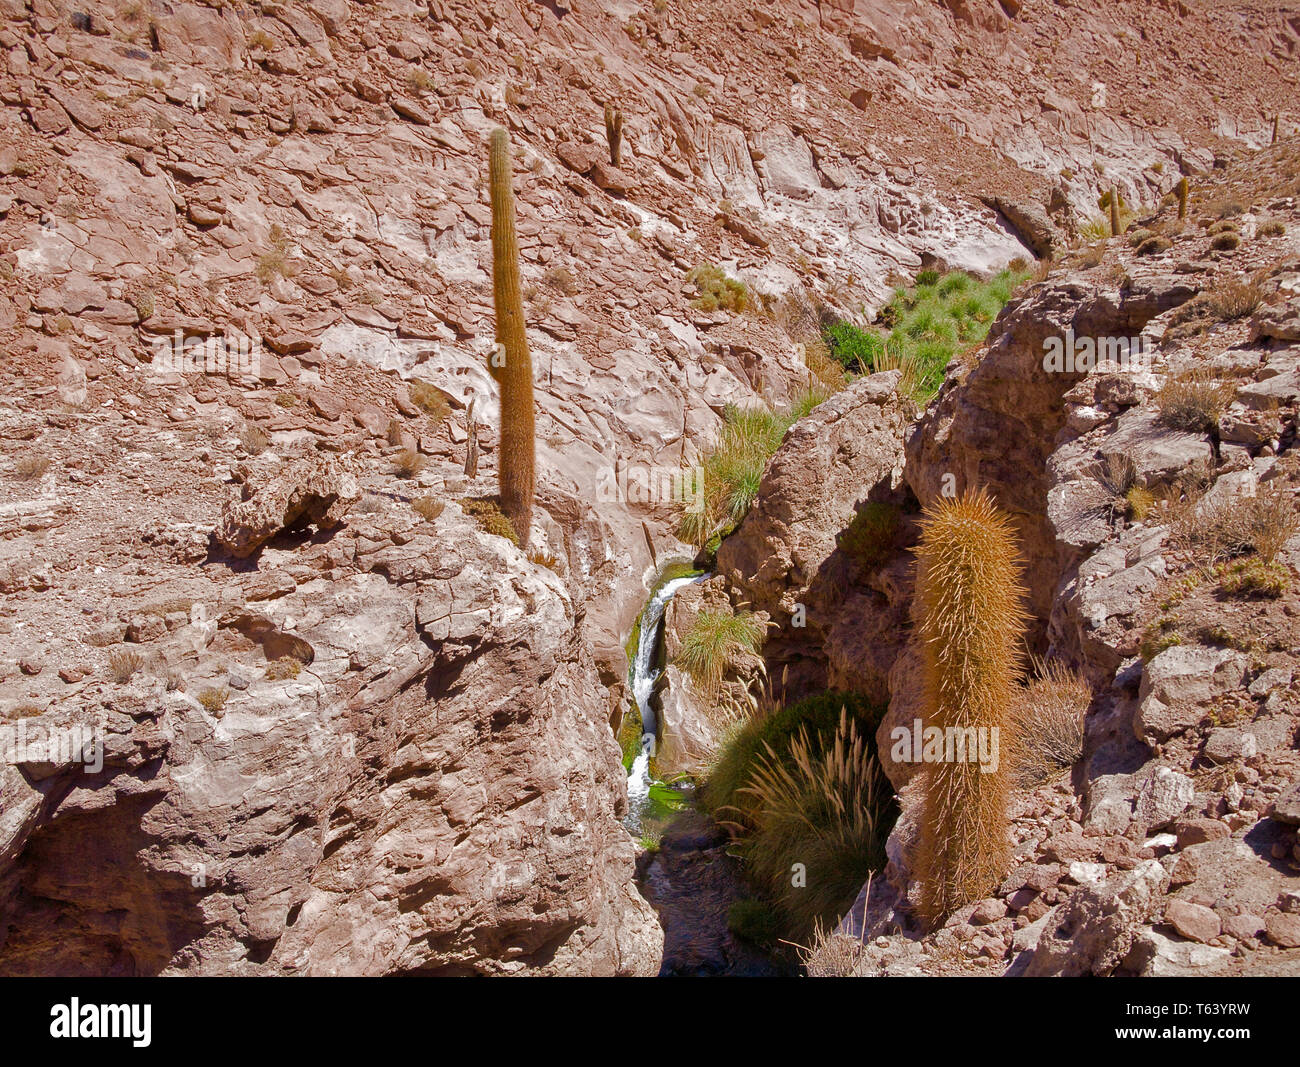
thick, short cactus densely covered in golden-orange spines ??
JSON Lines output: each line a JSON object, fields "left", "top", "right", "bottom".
{"left": 917, "top": 490, "right": 1026, "bottom": 925}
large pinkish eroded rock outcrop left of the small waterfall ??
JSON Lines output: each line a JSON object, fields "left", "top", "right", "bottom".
{"left": 0, "top": 507, "right": 662, "bottom": 975}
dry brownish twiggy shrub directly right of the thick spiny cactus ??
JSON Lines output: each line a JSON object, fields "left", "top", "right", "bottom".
{"left": 1011, "top": 660, "right": 1092, "bottom": 789}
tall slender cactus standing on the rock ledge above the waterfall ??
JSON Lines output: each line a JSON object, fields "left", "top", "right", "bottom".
{"left": 489, "top": 129, "right": 536, "bottom": 547}
